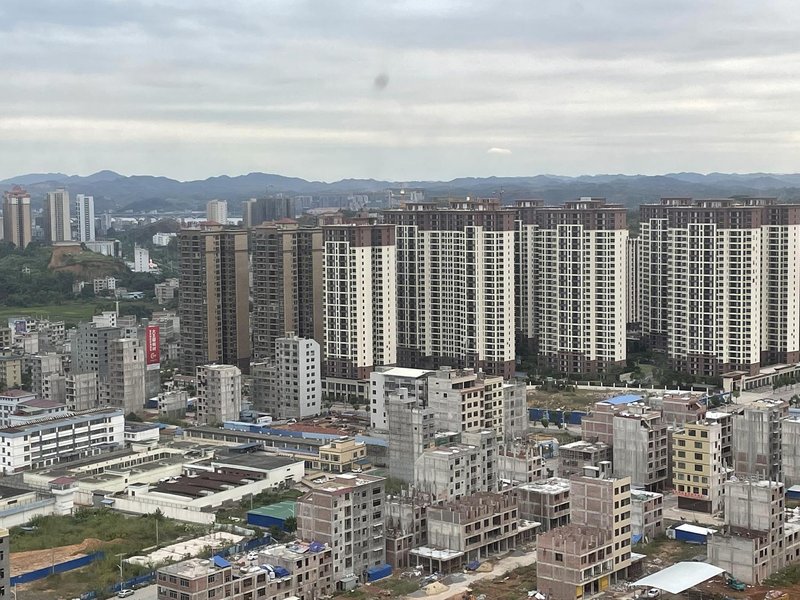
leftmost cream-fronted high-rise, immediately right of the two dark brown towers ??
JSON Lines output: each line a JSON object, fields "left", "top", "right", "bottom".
{"left": 323, "top": 219, "right": 399, "bottom": 398}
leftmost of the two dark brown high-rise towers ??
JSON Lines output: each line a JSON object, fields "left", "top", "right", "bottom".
{"left": 178, "top": 226, "right": 251, "bottom": 373}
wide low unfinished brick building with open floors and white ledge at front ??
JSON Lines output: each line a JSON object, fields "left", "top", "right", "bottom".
{"left": 411, "top": 492, "right": 537, "bottom": 573}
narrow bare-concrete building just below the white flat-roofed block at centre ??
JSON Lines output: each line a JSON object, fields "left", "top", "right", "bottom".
{"left": 386, "top": 390, "right": 436, "bottom": 483}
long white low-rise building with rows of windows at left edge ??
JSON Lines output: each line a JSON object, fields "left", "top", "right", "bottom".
{"left": 0, "top": 409, "right": 125, "bottom": 475}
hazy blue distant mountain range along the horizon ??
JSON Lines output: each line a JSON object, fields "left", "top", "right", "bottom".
{"left": 0, "top": 171, "right": 800, "bottom": 214}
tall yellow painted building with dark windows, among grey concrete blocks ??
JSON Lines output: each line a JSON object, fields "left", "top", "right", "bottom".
{"left": 672, "top": 421, "right": 728, "bottom": 514}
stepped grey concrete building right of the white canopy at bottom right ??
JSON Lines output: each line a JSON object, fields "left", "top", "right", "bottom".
{"left": 708, "top": 479, "right": 794, "bottom": 585}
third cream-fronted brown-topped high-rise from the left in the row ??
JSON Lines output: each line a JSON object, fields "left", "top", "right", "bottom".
{"left": 533, "top": 198, "right": 628, "bottom": 373}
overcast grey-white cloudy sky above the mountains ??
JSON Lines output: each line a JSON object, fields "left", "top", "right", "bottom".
{"left": 0, "top": 0, "right": 800, "bottom": 181}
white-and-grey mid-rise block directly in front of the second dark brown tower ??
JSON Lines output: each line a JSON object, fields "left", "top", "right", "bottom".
{"left": 251, "top": 332, "right": 322, "bottom": 419}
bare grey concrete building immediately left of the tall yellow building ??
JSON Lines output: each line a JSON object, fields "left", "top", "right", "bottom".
{"left": 613, "top": 403, "right": 669, "bottom": 491}
